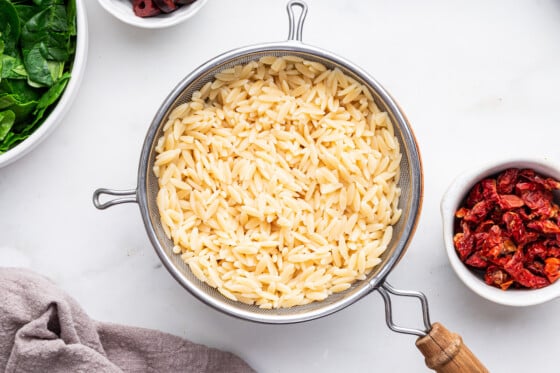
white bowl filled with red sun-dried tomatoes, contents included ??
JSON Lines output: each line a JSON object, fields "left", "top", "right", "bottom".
{"left": 441, "top": 159, "right": 560, "bottom": 306}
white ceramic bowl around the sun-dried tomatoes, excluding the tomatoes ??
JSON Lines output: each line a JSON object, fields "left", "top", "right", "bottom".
{"left": 441, "top": 158, "right": 560, "bottom": 306}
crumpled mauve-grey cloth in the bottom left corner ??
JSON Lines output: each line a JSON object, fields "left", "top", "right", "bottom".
{"left": 0, "top": 268, "right": 253, "bottom": 373}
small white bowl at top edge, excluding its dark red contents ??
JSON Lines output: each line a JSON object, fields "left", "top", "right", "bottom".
{"left": 99, "top": 0, "right": 207, "bottom": 29}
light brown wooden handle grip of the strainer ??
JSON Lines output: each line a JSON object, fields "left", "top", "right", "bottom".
{"left": 416, "top": 322, "right": 488, "bottom": 373}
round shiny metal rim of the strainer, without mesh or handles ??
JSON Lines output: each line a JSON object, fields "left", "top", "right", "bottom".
{"left": 137, "top": 40, "right": 423, "bottom": 324}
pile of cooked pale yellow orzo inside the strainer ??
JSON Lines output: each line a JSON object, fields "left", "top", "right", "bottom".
{"left": 154, "top": 56, "right": 401, "bottom": 308}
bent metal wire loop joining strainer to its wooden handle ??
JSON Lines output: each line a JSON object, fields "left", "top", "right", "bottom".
{"left": 377, "top": 282, "right": 432, "bottom": 337}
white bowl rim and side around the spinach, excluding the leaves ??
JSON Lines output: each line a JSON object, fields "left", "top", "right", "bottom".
{"left": 0, "top": 0, "right": 88, "bottom": 167}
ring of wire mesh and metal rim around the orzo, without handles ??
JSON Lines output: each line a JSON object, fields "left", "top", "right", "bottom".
{"left": 132, "top": 33, "right": 422, "bottom": 323}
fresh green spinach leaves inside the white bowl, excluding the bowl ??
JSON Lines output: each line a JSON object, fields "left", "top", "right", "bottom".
{"left": 0, "top": 0, "right": 76, "bottom": 154}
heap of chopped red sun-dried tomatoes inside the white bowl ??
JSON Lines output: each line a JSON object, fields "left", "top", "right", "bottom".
{"left": 453, "top": 168, "right": 560, "bottom": 290}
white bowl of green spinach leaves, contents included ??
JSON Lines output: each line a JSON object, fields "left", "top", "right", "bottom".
{"left": 0, "top": 0, "right": 88, "bottom": 167}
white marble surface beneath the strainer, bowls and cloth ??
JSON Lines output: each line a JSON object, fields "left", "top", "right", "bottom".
{"left": 0, "top": 0, "right": 560, "bottom": 372}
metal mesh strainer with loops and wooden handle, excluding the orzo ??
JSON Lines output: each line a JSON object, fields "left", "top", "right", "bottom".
{"left": 93, "top": 1, "right": 485, "bottom": 372}
